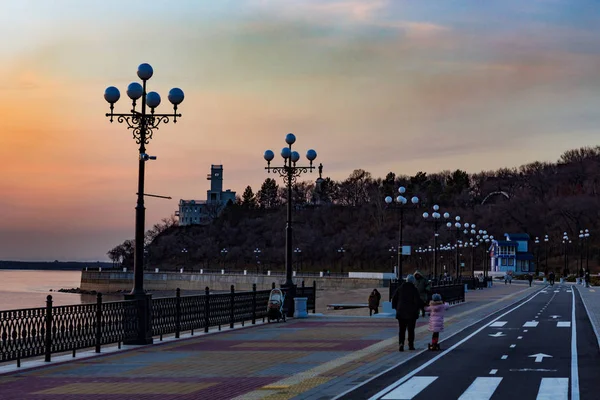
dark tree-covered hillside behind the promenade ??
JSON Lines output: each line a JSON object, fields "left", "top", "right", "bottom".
{"left": 108, "top": 146, "right": 600, "bottom": 272}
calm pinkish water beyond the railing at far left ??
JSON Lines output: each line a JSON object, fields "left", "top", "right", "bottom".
{"left": 0, "top": 270, "right": 123, "bottom": 310}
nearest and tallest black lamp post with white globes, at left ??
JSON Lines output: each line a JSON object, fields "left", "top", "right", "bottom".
{"left": 104, "top": 63, "right": 184, "bottom": 344}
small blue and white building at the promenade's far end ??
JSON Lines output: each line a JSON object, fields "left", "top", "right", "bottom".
{"left": 490, "top": 233, "right": 535, "bottom": 274}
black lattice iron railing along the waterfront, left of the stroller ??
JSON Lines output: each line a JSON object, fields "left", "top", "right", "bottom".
{"left": 0, "top": 282, "right": 316, "bottom": 366}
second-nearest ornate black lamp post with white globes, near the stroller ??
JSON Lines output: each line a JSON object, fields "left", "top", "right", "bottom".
{"left": 264, "top": 133, "right": 317, "bottom": 317}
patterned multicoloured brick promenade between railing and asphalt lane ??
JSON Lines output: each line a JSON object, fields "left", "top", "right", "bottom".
{"left": 0, "top": 283, "right": 597, "bottom": 400}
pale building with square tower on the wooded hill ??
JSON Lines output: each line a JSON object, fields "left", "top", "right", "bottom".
{"left": 175, "top": 165, "right": 235, "bottom": 226}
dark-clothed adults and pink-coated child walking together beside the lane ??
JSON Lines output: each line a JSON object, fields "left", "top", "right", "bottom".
{"left": 392, "top": 271, "right": 449, "bottom": 351}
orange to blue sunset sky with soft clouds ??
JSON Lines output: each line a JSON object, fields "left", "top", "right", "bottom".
{"left": 0, "top": 0, "right": 600, "bottom": 261}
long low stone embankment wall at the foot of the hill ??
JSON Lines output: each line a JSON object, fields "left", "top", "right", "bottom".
{"left": 80, "top": 271, "right": 388, "bottom": 293}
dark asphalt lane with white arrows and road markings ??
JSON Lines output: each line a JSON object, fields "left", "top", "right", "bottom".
{"left": 338, "top": 284, "right": 600, "bottom": 400}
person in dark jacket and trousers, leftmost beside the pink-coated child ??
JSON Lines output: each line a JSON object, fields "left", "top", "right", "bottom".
{"left": 392, "top": 275, "right": 423, "bottom": 351}
